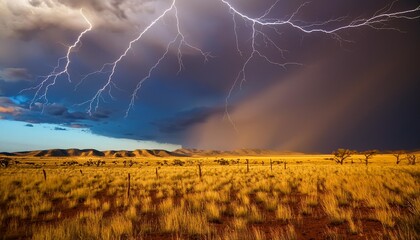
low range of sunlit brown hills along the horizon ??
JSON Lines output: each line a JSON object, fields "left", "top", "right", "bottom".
{"left": 0, "top": 148, "right": 302, "bottom": 158}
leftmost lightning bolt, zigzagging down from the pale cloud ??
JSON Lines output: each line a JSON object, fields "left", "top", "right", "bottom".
{"left": 20, "top": 9, "right": 93, "bottom": 107}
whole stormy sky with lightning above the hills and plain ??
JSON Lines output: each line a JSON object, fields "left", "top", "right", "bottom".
{"left": 0, "top": 0, "right": 420, "bottom": 152}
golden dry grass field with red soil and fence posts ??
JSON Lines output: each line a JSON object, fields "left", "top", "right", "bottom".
{"left": 0, "top": 155, "right": 420, "bottom": 240}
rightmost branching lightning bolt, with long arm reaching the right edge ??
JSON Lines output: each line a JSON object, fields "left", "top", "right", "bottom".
{"left": 220, "top": 0, "right": 420, "bottom": 131}
